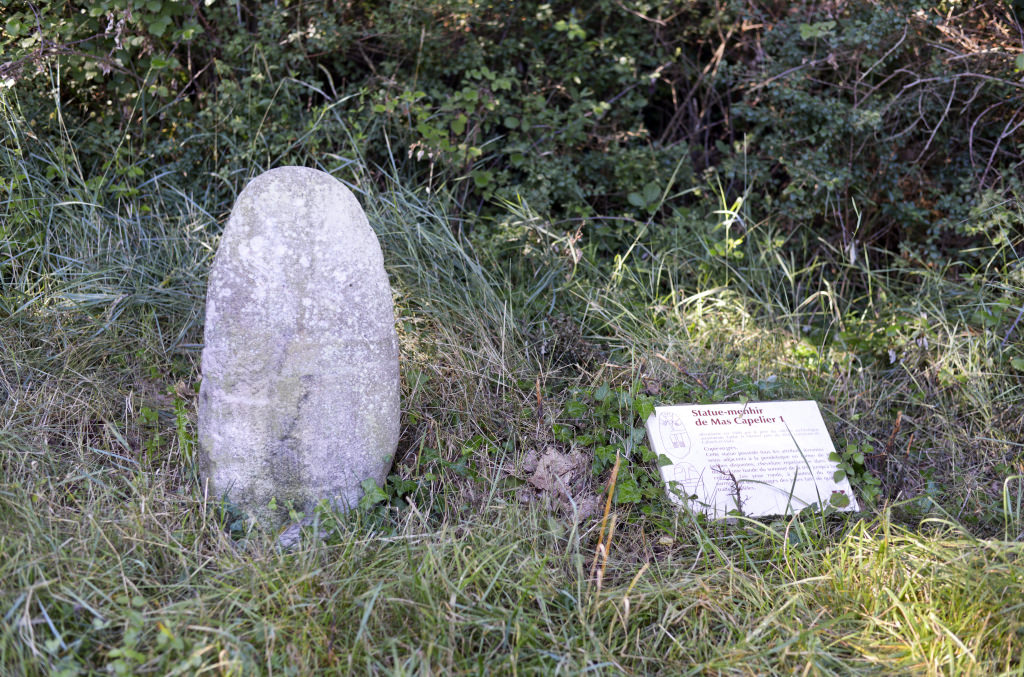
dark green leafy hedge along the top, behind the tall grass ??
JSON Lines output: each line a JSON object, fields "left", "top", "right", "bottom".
{"left": 8, "top": 0, "right": 1024, "bottom": 259}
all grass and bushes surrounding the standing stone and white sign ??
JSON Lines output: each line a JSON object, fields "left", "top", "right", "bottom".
{"left": 6, "top": 0, "right": 1024, "bottom": 675}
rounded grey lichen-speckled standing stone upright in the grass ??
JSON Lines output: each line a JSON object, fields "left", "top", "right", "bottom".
{"left": 199, "top": 167, "right": 400, "bottom": 525}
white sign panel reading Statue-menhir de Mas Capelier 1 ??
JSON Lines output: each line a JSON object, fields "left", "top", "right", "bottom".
{"left": 647, "top": 400, "right": 859, "bottom": 518}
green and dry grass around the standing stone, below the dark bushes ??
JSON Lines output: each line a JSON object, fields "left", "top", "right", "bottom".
{"left": 0, "top": 82, "right": 1024, "bottom": 675}
